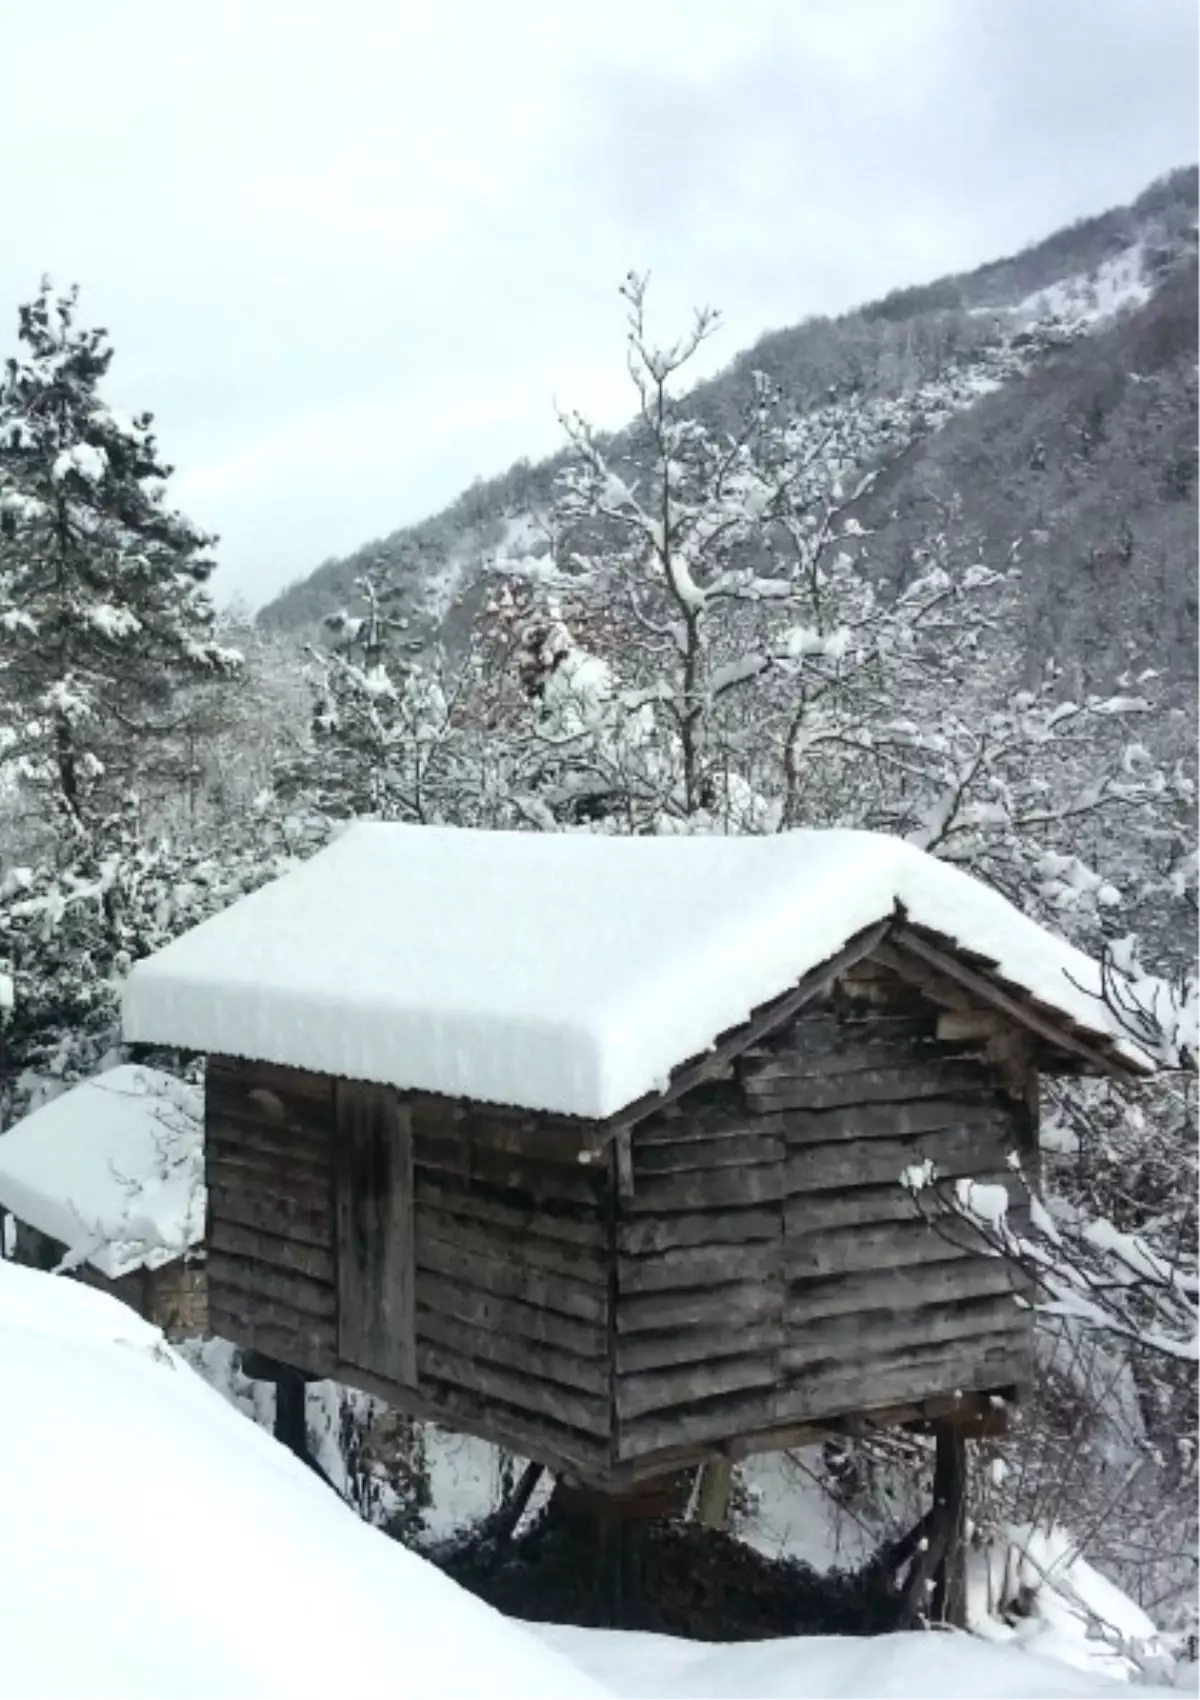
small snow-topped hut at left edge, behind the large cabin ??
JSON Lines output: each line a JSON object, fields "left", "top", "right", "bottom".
{"left": 0, "top": 1064, "right": 209, "bottom": 1340}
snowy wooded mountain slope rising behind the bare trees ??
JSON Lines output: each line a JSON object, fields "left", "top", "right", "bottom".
{"left": 262, "top": 167, "right": 1200, "bottom": 683}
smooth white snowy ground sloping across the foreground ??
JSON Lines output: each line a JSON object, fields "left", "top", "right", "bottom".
{"left": 0, "top": 1263, "right": 1176, "bottom": 1700}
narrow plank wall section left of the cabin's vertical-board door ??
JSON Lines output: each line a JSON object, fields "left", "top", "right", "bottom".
{"left": 204, "top": 1057, "right": 337, "bottom": 1375}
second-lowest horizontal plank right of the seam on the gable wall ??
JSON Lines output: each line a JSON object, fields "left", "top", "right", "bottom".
{"left": 778, "top": 1294, "right": 1033, "bottom": 1375}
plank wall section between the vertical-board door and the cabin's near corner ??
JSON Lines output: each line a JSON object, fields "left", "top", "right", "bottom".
{"left": 410, "top": 1097, "right": 615, "bottom": 1469}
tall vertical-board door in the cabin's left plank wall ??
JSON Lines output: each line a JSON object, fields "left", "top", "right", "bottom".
{"left": 337, "top": 1081, "right": 416, "bottom": 1387}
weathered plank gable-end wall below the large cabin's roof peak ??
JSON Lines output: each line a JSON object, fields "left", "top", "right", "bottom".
{"left": 617, "top": 993, "right": 1030, "bottom": 1460}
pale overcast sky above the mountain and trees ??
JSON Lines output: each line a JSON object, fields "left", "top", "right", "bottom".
{"left": 0, "top": 0, "right": 1200, "bottom": 602}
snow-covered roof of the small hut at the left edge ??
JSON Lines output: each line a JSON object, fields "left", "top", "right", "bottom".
{"left": 0, "top": 1064, "right": 204, "bottom": 1278}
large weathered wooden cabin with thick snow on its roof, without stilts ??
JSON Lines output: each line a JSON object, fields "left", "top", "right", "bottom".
{"left": 124, "top": 825, "right": 1144, "bottom": 1493}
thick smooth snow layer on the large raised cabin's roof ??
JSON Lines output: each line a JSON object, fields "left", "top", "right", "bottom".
{"left": 124, "top": 823, "right": 1128, "bottom": 1117}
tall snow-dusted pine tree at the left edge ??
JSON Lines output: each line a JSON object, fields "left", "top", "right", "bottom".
{"left": 0, "top": 282, "right": 238, "bottom": 842}
